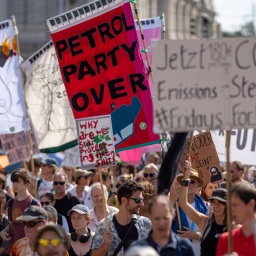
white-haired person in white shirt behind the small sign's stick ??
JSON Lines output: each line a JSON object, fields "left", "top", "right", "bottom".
{"left": 88, "top": 182, "right": 118, "bottom": 232}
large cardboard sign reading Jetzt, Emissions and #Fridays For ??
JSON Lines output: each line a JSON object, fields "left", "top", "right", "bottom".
{"left": 152, "top": 38, "right": 256, "bottom": 132}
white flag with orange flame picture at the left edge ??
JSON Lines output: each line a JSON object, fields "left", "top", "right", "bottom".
{"left": 0, "top": 20, "right": 27, "bottom": 134}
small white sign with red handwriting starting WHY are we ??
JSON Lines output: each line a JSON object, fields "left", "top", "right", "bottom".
{"left": 76, "top": 115, "right": 115, "bottom": 169}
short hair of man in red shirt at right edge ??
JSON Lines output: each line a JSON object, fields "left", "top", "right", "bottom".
{"left": 230, "top": 182, "right": 256, "bottom": 211}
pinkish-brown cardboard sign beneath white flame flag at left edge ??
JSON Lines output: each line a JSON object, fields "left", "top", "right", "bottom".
{"left": 0, "top": 132, "right": 39, "bottom": 164}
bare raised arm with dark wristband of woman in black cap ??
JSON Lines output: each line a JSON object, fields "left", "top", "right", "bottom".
{"left": 179, "top": 161, "right": 208, "bottom": 233}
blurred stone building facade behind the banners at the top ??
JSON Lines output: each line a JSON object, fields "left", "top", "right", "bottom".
{"left": 0, "top": 0, "right": 218, "bottom": 59}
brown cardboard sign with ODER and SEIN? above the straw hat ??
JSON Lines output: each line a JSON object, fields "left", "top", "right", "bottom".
{"left": 181, "top": 132, "right": 222, "bottom": 184}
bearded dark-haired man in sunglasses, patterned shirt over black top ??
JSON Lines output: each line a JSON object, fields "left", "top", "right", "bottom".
{"left": 92, "top": 180, "right": 151, "bottom": 256}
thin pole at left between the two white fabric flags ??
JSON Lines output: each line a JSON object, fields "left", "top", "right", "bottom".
{"left": 11, "top": 15, "right": 36, "bottom": 184}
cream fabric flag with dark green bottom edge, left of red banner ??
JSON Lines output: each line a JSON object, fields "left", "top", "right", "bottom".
{"left": 21, "top": 42, "right": 77, "bottom": 153}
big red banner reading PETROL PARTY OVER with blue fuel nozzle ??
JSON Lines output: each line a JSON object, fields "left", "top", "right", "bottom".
{"left": 47, "top": 1, "right": 158, "bottom": 150}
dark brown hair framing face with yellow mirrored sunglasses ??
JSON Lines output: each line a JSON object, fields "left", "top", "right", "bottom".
{"left": 34, "top": 224, "right": 70, "bottom": 252}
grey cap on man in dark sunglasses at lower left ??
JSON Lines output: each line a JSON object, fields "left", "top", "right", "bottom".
{"left": 16, "top": 205, "right": 48, "bottom": 221}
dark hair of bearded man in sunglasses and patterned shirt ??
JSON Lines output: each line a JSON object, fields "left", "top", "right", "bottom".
{"left": 117, "top": 180, "right": 143, "bottom": 204}
